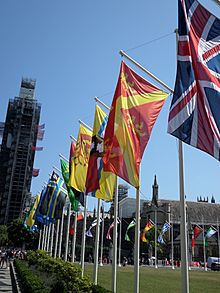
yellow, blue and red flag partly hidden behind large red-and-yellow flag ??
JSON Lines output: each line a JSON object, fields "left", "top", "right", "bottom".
{"left": 86, "top": 105, "right": 116, "bottom": 201}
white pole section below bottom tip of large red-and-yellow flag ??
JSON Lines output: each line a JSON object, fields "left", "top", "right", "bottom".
{"left": 134, "top": 188, "right": 140, "bottom": 293}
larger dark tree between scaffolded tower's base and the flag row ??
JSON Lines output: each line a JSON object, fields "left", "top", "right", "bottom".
{"left": 8, "top": 218, "right": 38, "bottom": 249}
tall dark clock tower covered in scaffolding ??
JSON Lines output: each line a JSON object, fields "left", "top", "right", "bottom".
{"left": 0, "top": 79, "right": 41, "bottom": 224}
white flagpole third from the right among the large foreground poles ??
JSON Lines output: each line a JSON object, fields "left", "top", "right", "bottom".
{"left": 112, "top": 177, "right": 118, "bottom": 293}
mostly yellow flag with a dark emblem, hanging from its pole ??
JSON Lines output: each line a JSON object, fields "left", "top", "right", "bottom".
{"left": 69, "top": 124, "right": 92, "bottom": 192}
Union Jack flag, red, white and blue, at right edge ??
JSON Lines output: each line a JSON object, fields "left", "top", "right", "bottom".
{"left": 168, "top": 0, "right": 220, "bottom": 160}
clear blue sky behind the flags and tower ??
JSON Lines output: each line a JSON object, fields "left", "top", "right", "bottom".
{"left": 0, "top": 0, "right": 220, "bottom": 209}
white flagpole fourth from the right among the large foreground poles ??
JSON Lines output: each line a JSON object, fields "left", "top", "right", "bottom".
{"left": 93, "top": 198, "right": 101, "bottom": 285}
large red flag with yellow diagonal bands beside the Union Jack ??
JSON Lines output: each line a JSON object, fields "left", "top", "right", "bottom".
{"left": 103, "top": 61, "right": 168, "bottom": 188}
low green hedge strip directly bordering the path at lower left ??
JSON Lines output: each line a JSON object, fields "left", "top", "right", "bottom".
{"left": 15, "top": 260, "right": 49, "bottom": 293}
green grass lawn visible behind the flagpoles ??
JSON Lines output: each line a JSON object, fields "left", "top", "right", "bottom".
{"left": 85, "top": 265, "right": 220, "bottom": 293}
